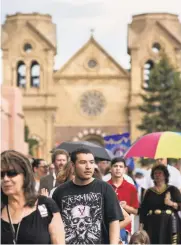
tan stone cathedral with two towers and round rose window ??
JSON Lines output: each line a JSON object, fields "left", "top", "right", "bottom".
{"left": 1, "top": 13, "right": 181, "bottom": 159}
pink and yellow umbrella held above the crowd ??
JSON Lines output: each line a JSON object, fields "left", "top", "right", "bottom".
{"left": 124, "top": 131, "right": 181, "bottom": 159}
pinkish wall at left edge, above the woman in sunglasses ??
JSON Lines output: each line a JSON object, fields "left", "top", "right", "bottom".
{"left": 1, "top": 86, "right": 28, "bottom": 154}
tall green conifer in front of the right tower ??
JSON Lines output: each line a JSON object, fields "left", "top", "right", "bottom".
{"left": 138, "top": 54, "right": 181, "bottom": 133}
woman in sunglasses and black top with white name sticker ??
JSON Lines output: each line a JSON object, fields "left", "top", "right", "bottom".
{"left": 1, "top": 150, "right": 65, "bottom": 244}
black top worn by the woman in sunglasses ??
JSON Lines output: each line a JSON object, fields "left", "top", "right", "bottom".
{"left": 1, "top": 196, "right": 59, "bottom": 244}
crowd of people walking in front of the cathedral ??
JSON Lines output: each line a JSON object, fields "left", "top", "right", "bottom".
{"left": 1, "top": 148, "right": 181, "bottom": 244}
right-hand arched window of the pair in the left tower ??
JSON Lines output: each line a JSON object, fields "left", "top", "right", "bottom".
{"left": 30, "top": 61, "right": 40, "bottom": 88}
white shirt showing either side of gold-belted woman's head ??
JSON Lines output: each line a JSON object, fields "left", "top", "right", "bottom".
{"left": 142, "top": 165, "right": 181, "bottom": 190}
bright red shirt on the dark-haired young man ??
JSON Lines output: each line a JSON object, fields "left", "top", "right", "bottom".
{"left": 108, "top": 179, "right": 139, "bottom": 232}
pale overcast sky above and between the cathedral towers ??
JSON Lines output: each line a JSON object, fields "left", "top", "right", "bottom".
{"left": 1, "top": 0, "right": 181, "bottom": 69}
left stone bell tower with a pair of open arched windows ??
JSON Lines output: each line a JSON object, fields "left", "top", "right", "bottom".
{"left": 2, "top": 13, "right": 56, "bottom": 160}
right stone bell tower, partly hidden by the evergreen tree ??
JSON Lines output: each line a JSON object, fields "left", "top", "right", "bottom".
{"left": 128, "top": 13, "right": 181, "bottom": 141}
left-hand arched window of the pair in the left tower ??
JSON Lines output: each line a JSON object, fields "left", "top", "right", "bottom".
{"left": 17, "top": 61, "right": 26, "bottom": 88}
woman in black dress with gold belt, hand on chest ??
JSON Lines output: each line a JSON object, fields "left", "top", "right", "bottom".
{"left": 140, "top": 164, "right": 181, "bottom": 244}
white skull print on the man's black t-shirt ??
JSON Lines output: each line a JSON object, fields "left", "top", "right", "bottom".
{"left": 62, "top": 192, "right": 102, "bottom": 244}
